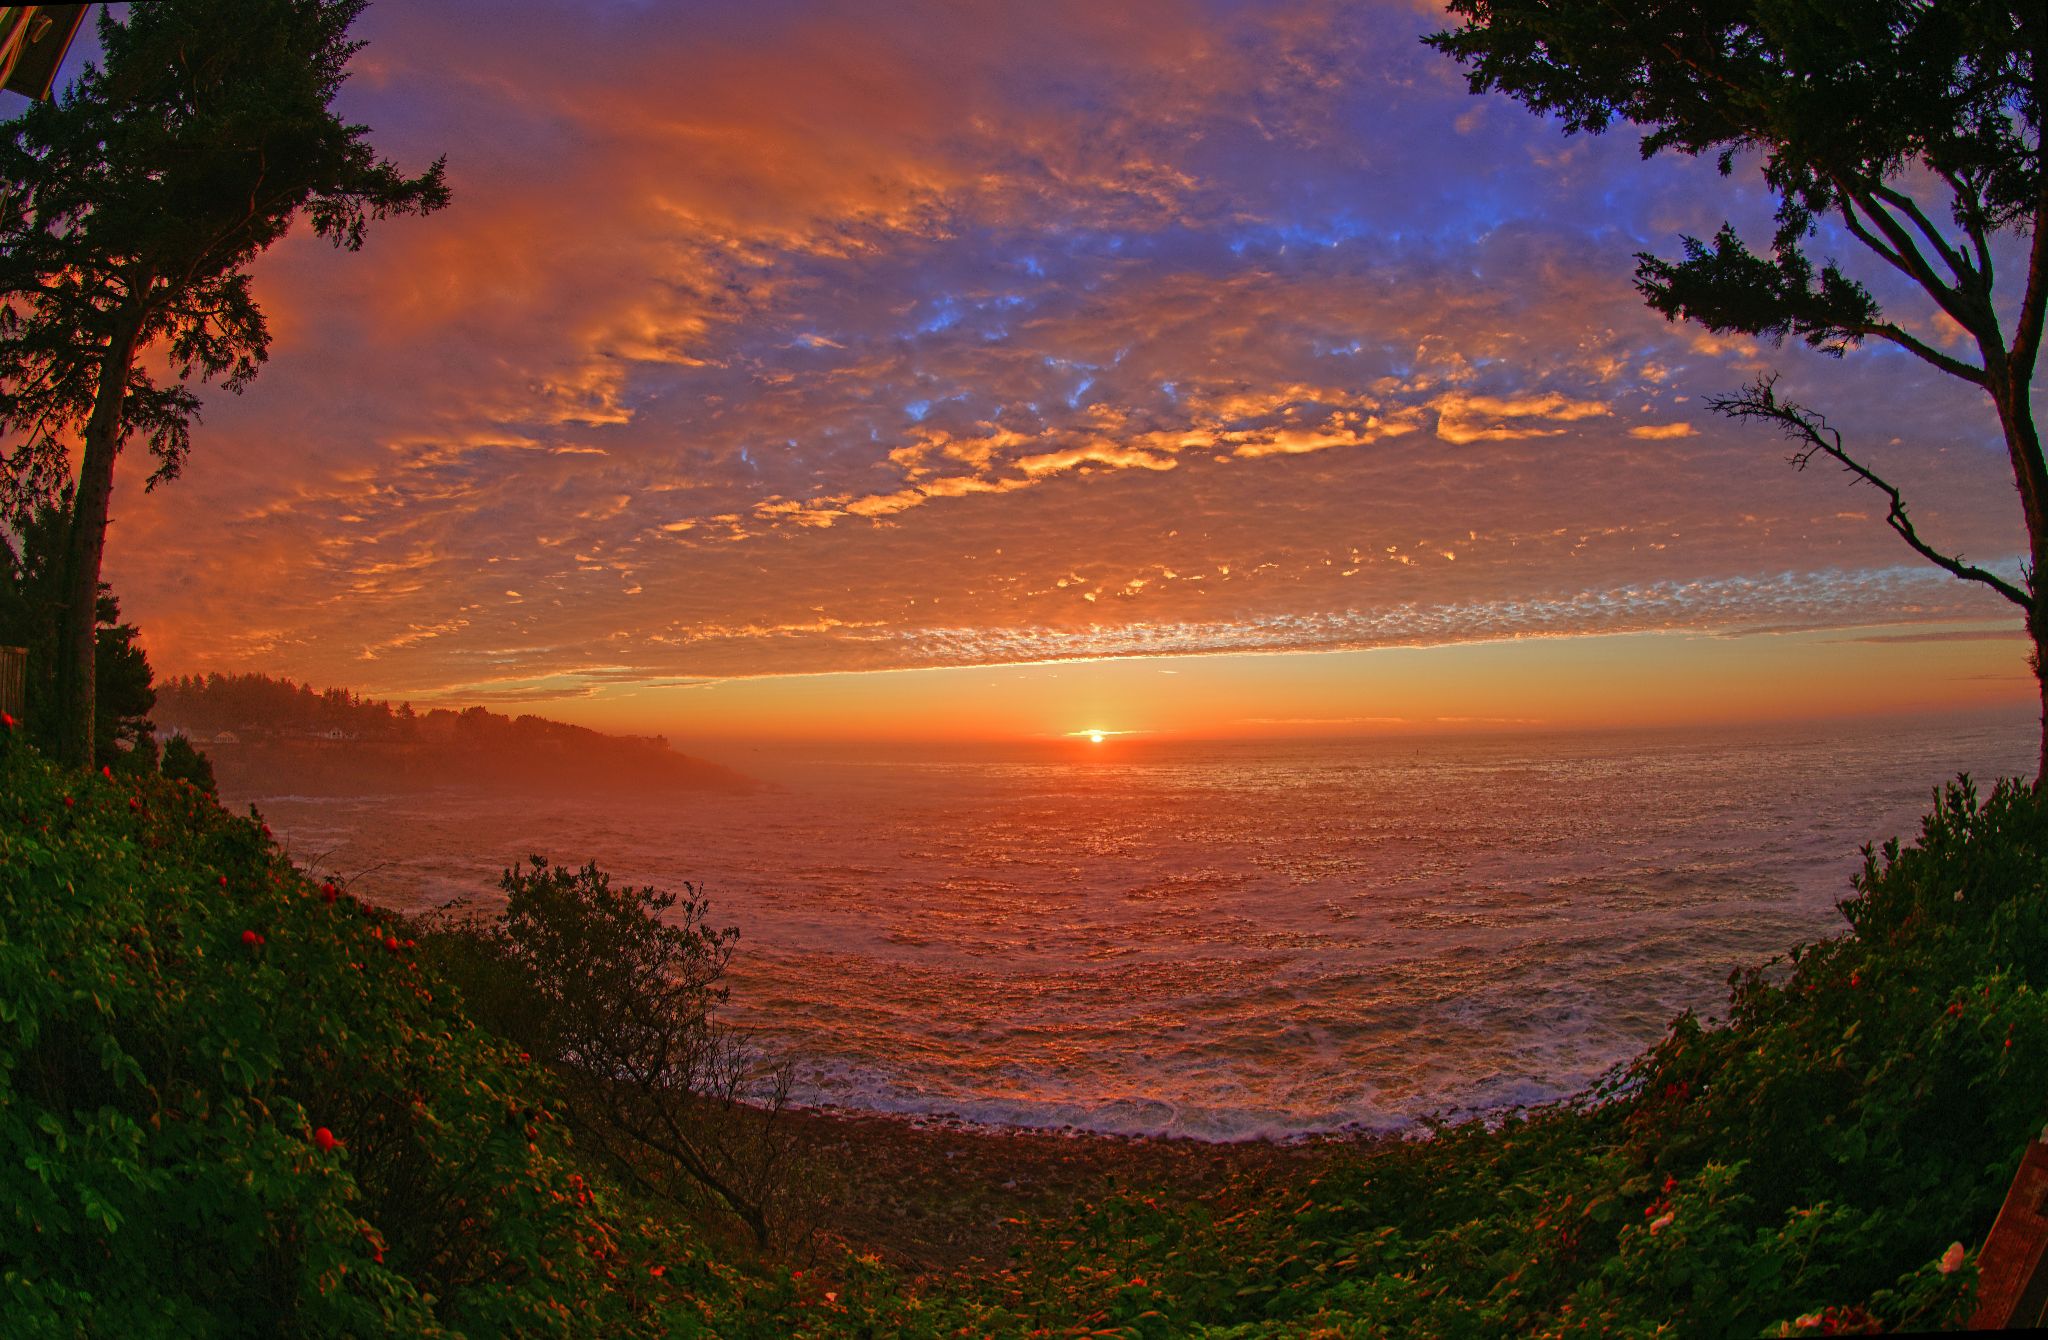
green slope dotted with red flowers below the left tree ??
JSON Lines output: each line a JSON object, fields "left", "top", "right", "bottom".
{"left": 0, "top": 746, "right": 761, "bottom": 1336}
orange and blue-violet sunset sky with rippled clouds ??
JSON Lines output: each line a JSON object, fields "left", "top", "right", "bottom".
{"left": 72, "top": 0, "right": 2034, "bottom": 740}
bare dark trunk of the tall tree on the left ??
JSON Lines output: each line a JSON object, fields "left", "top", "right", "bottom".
{"left": 51, "top": 313, "right": 141, "bottom": 768}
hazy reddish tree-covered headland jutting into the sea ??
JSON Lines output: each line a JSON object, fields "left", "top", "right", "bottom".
{"left": 154, "top": 674, "right": 750, "bottom": 791}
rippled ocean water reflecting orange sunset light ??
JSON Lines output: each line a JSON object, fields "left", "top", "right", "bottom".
{"left": 251, "top": 719, "right": 2038, "bottom": 1139}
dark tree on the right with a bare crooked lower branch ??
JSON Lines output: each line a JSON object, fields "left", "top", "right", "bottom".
{"left": 1425, "top": 0, "right": 2048, "bottom": 785}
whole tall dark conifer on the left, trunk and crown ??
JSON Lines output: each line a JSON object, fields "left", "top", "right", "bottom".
{"left": 0, "top": 0, "right": 449, "bottom": 762}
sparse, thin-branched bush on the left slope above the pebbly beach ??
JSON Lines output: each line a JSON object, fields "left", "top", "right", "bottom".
{"left": 424, "top": 856, "right": 788, "bottom": 1244}
